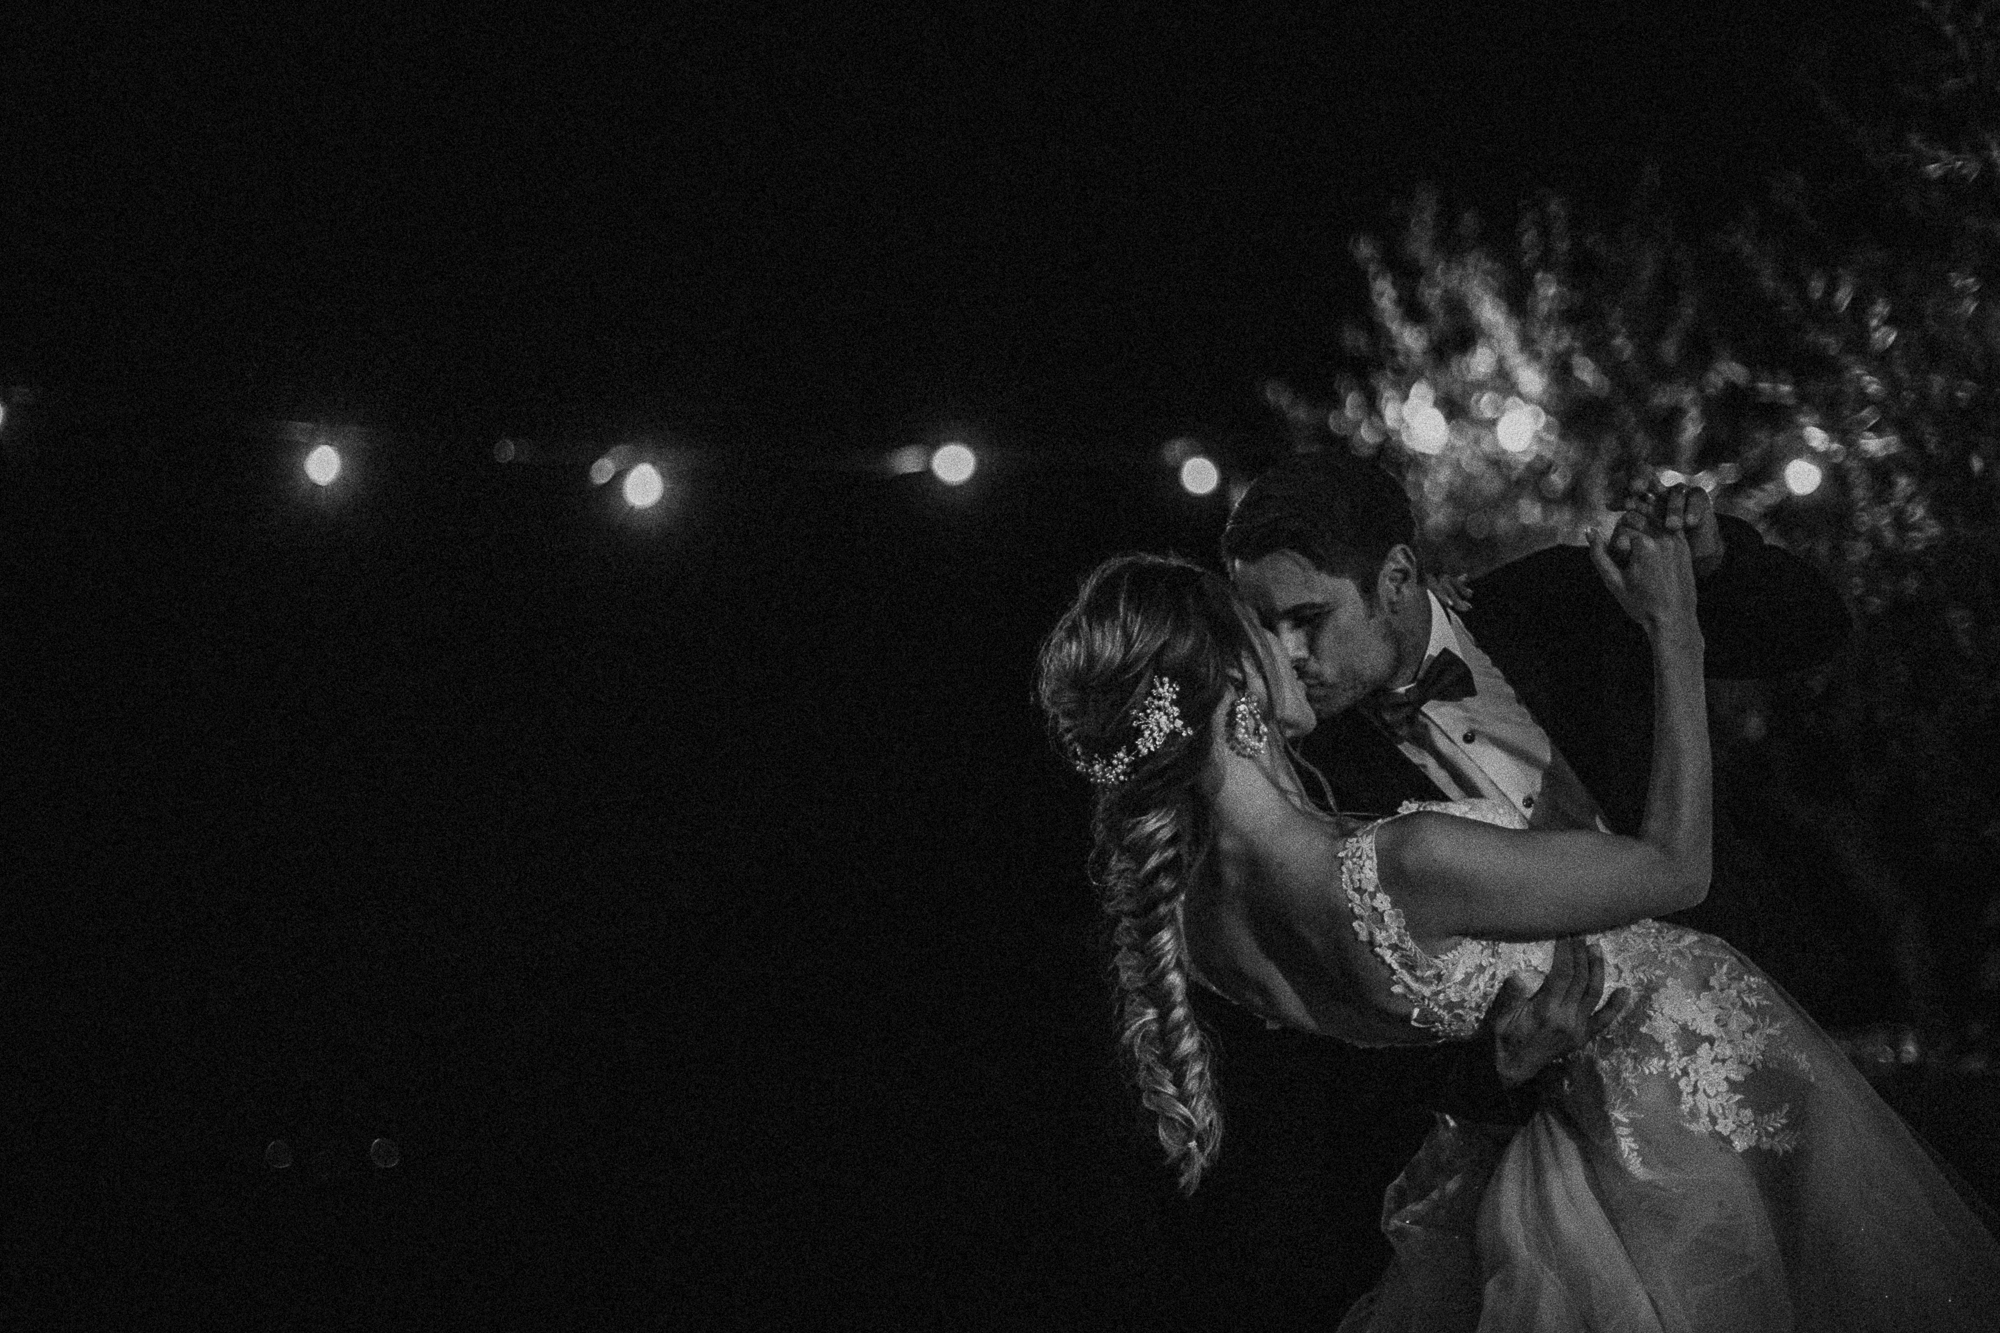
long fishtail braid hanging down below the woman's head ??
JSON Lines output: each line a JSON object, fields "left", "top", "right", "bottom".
{"left": 1098, "top": 801, "right": 1222, "bottom": 1195}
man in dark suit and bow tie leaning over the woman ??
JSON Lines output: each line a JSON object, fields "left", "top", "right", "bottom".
{"left": 1222, "top": 452, "right": 1848, "bottom": 835}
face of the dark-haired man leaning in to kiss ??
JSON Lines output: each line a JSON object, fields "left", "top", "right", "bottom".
{"left": 1230, "top": 550, "right": 1400, "bottom": 719}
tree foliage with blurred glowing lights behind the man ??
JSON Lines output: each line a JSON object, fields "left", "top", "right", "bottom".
{"left": 1270, "top": 0, "right": 2000, "bottom": 1040}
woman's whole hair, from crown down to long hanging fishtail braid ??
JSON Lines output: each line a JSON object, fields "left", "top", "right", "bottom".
{"left": 1036, "top": 554, "right": 1256, "bottom": 1193}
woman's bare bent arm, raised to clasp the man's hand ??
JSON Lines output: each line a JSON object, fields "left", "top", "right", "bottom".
{"left": 1376, "top": 512, "right": 1712, "bottom": 939}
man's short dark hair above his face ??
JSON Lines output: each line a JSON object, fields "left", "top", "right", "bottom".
{"left": 1222, "top": 448, "right": 1416, "bottom": 600}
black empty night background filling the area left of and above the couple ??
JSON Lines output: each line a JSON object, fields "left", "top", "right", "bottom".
{"left": 0, "top": 4, "right": 1936, "bottom": 1327}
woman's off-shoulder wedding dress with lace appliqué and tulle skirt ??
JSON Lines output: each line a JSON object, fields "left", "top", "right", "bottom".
{"left": 1340, "top": 801, "right": 2000, "bottom": 1333}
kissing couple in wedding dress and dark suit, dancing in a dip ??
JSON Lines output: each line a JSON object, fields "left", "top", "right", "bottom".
{"left": 1038, "top": 452, "right": 2000, "bottom": 1333}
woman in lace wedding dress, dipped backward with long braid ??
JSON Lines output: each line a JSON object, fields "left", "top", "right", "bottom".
{"left": 1038, "top": 532, "right": 2000, "bottom": 1333}
